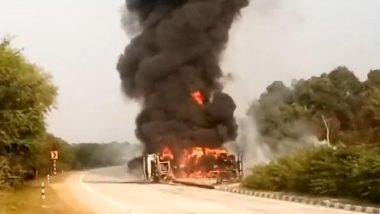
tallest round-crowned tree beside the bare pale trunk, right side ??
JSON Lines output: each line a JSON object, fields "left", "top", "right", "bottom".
{"left": 295, "top": 66, "right": 364, "bottom": 141}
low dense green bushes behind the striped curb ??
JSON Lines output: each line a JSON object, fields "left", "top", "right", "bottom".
{"left": 243, "top": 146, "right": 380, "bottom": 202}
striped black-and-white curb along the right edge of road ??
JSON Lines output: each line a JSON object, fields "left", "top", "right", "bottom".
{"left": 215, "top": 187, "right": 380, "bottom": 214}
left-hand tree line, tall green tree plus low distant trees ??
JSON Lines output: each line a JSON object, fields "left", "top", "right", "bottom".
{"left": 0, "top": 40, "right": 133, "bottom": 188}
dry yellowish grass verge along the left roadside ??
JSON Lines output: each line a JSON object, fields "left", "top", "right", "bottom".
{"left": 0, "top": 173, "right": 89, "bottom": 214}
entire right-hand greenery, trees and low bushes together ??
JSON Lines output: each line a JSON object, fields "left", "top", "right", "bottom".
{"left": 243, "top": 66, "right": 380, "bottom": 203}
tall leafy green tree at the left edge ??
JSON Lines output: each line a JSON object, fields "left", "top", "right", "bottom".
{"left": 0, "top": 40, "right": 57, "bottom": 186}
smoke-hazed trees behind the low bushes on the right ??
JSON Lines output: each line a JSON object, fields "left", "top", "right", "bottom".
{"left": 248, "top": 66, "right": 380, "bottom": 149}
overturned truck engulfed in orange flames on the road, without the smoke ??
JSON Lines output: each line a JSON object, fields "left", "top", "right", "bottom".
{"left": 142, "top": 144, "right": 243, "bottom": 183}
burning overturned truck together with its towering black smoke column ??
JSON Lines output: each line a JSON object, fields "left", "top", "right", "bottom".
{"left": 117, "top": 0, "right": 249, "bottom": 181}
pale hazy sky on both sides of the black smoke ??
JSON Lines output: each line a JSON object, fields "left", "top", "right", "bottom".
{"left": 0, "top": 0, "right": 380, "bottom": 142}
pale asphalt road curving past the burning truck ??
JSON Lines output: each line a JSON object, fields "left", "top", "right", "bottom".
{"left": 66, "top": 167, "right": 362, "bottom": 214}
